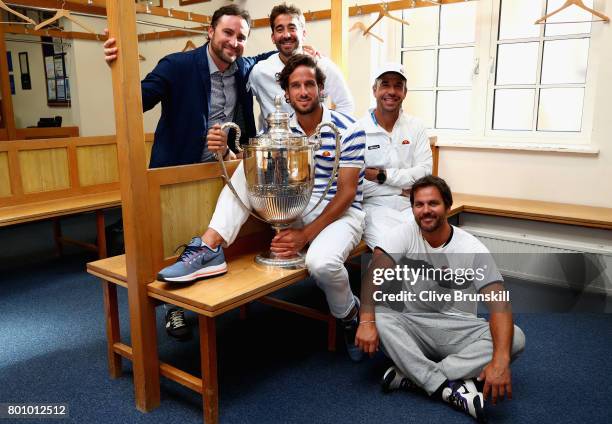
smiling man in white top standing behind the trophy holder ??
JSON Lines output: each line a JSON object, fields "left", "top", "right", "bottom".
{"left": 249, "top": 3, "right": 355, "bottom": 130}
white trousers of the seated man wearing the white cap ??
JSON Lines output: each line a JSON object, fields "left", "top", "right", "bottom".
{"left": 363, "top": 195, "right": 414, "bottom": 253}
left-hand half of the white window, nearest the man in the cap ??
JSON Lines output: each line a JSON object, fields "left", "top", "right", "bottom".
{"left": 402, "top": 2, "right": 477, "bottom": 130}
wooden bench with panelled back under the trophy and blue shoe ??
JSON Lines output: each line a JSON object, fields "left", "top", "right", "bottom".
{"left": 87, "top": 157, "right": 380, "bottom": 422}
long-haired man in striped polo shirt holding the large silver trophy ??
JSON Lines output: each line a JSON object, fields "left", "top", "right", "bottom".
{"left": 158, "top": 54, "right": 365, "bottom": 361}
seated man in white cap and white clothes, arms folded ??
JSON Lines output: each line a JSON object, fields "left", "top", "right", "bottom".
{"left": 359, "top": 63, "right": 432, "bottom": 253}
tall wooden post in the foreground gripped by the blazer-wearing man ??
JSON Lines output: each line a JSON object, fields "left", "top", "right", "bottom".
{"left": 106, "top": 0, "right": 159, "bottom": 411}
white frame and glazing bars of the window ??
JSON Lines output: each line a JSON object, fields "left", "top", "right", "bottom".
{"left": 399, "top": 0, "right": 603, "bottom": 147}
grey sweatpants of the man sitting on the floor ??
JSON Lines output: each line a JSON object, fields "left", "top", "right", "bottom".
{"left": 376, "top": 309, "right": 525, "bottom": 395}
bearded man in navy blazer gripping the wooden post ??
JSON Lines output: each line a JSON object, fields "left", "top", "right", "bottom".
{"left": 104, "top": 5, "right": 273, "bottom": 340}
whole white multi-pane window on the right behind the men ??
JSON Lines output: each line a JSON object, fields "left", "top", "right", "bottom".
{"left": 400, "top": 0, "right": 593, "bottom": 143}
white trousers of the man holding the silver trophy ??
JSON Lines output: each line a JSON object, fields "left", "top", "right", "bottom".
{"left": 209, "top": 163, "right": 365, "bottom": 318}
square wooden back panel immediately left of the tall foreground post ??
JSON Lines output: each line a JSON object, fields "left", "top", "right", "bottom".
{"left": 77, "top": 144, "right": 119, "bottom": 186}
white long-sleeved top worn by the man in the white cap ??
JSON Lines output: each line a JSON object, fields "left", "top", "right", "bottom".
{"left": 359, "top": 109, "right": 433, "bottom": 199}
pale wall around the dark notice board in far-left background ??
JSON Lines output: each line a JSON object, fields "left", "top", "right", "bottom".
{"left": 6, "top": 34, "right": 75, "bottom": 128}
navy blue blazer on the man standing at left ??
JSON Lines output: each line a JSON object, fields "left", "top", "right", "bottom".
{"left": 141, "top": 43, "right": 275, "bottom": 168}
